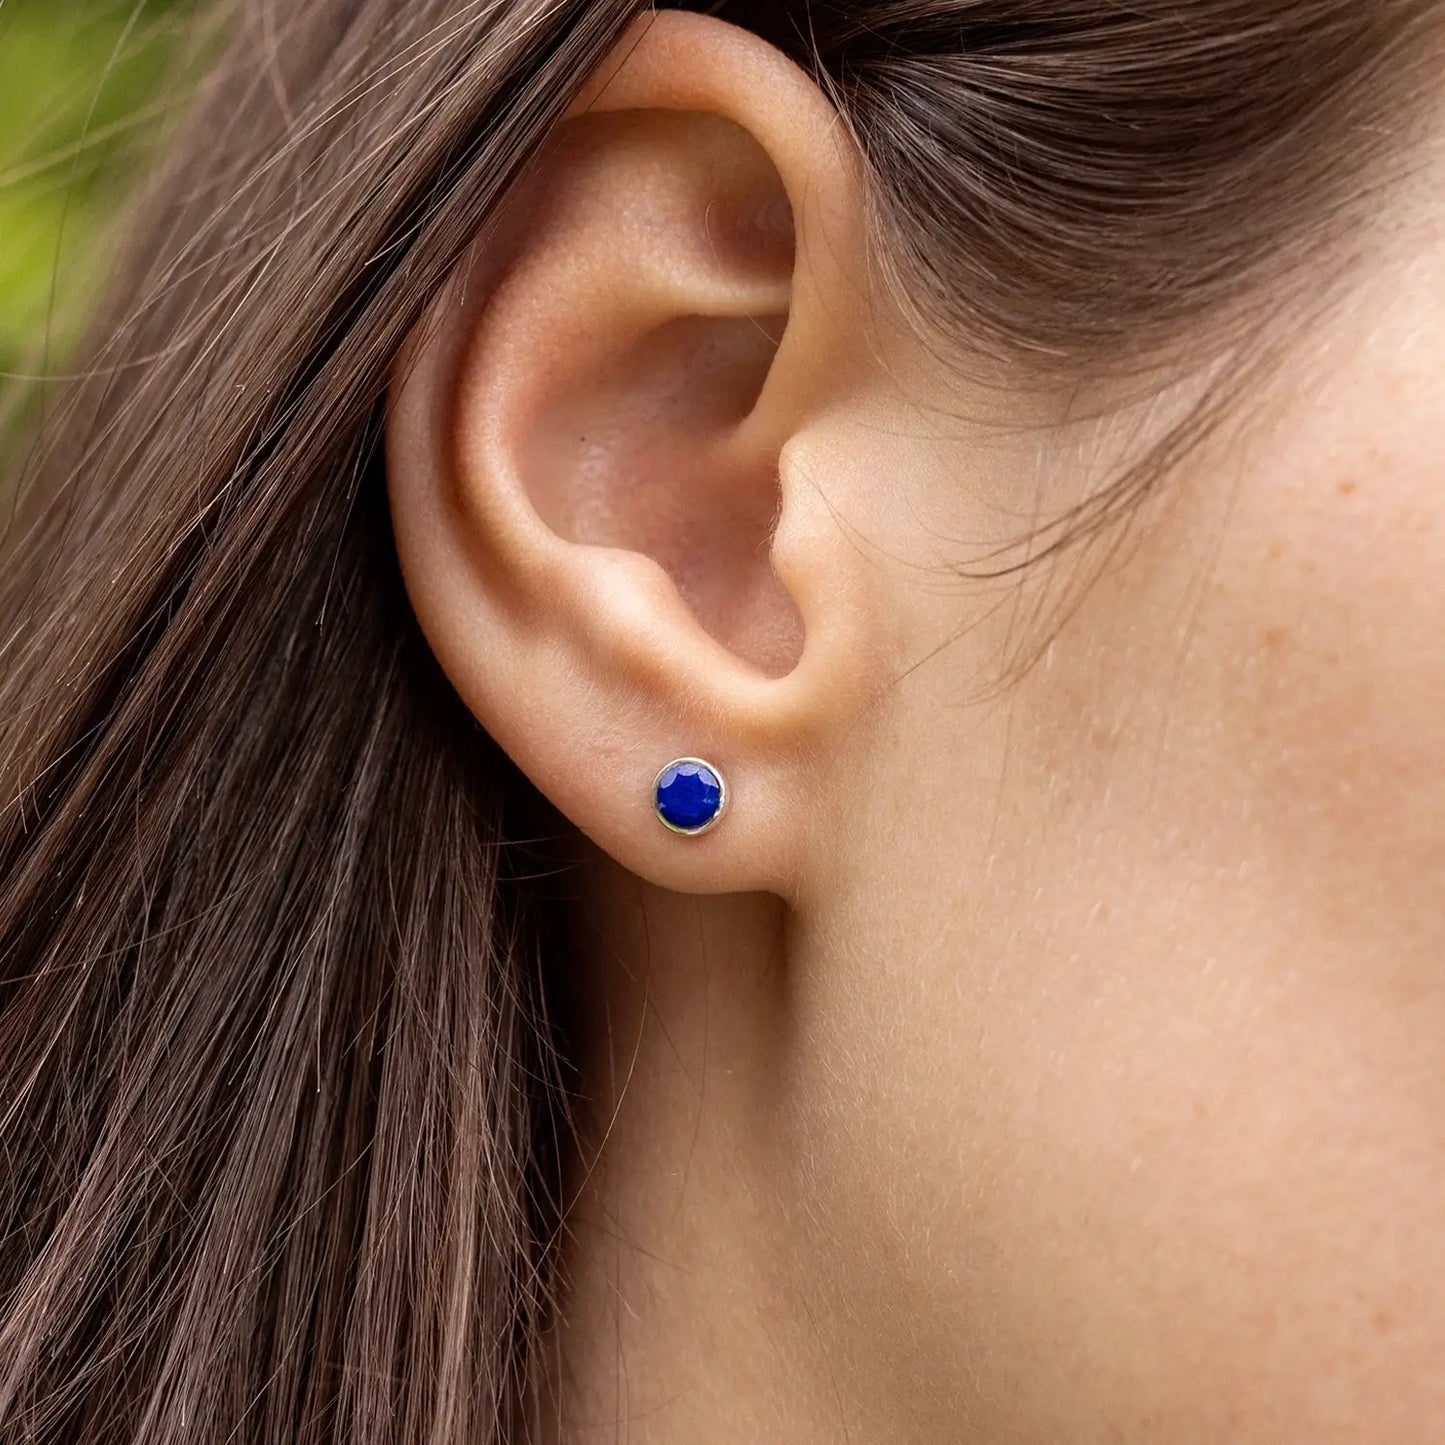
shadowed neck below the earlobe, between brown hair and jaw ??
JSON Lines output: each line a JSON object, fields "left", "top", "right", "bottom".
{"left": 549, "top": 854, "right": 855, "bottom": 1445}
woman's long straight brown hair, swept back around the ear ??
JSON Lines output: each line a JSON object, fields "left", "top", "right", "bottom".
{"left": 0, "top": 0, "right": 1438, "bottom": 1445}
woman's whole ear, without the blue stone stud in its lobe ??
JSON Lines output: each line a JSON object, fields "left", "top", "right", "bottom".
{"left": 387, "top": 13, "right": 889, "bottom": 896}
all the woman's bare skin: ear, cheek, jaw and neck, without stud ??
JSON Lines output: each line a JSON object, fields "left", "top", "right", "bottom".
{"left": 389, "top": 14, "right": 1445, "bottom": 1445}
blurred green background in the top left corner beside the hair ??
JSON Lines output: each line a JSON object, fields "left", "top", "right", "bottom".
{"left": 0, "top": 0, "right": 198, "bottom": 376}
